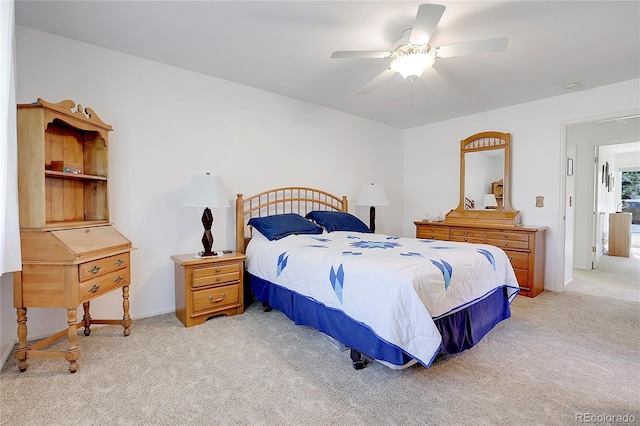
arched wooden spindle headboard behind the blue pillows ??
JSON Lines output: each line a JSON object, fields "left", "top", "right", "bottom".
{"left": 236, "top": 186, "right": 349, "bottom": 253}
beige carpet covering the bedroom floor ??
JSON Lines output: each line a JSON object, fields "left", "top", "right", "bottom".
{"left": 0, "top": 253, "right": 640, "bottom": 425}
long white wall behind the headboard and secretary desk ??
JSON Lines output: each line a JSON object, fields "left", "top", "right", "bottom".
{"left": 0, "top": 27, "right": 402, "bottom": 348}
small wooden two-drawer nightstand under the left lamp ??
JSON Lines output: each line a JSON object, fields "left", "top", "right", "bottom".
{"left": 171, "top": 252, "right": 246, "bottom": 327}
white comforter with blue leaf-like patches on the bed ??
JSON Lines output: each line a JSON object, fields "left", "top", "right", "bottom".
{"left": 246, "top": 230, "right": 518, "bottom": 365}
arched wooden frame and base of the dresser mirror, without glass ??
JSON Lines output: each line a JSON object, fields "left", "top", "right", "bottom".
{"left": 445, "top": 131, "right": 521, "bottom": 226}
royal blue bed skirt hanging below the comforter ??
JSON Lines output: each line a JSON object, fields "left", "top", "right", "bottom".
{"left": 247, "top": 273, "right": 511, "bottom": 367}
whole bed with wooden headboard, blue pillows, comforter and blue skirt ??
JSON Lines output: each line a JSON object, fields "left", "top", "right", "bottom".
{"left": 236, "top": 187, "right": 519, "bottom": 369}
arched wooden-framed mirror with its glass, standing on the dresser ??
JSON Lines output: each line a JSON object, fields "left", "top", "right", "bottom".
{"left": 445, "top": 132, "right": 520, "bottom": 226}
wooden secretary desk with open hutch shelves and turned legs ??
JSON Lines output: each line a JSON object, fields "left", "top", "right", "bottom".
{"left": 13, "top": 99, "right": 132, "bottom": 373}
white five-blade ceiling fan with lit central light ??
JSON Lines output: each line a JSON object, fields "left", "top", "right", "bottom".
{"left": 331, "top": 3, "right": 509, "bottom": 94}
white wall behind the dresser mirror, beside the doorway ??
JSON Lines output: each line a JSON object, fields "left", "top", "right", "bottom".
{"left": 403, "top": 80, "right": 640, "bottom": 290}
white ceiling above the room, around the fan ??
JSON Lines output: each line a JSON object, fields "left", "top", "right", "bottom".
{"left": 15, "top": 0, "right": 640, "bottom": 128}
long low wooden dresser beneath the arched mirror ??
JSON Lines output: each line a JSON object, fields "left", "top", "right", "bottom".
{"left": 414, "top": 221, "right": 547, "bottom": 297}
